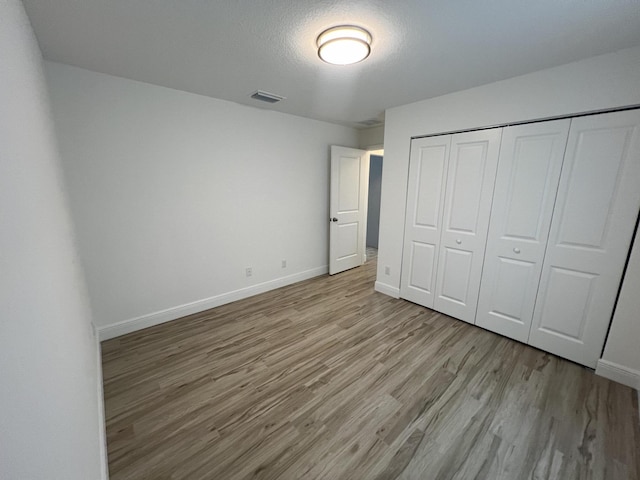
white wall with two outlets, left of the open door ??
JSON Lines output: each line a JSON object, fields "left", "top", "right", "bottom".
{"left": 45, "top": 62, "right": 358, "bottom": 338}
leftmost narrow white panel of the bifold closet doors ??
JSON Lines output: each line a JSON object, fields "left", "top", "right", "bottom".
{"left": 400, "top": 135, "right": 451, "bottom": 308}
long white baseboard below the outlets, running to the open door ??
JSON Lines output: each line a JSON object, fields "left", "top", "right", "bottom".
{"left": 98, "top": 265, "right": 329, "bottom": 341}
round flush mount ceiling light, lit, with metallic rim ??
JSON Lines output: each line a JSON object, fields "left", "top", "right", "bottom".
{"left": 317, "top": 25, "right": 371, "bottom": 65}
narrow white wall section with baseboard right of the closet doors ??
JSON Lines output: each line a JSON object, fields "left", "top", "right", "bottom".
{"left": 596, "top": 234, "right": 640, "bottom": 390}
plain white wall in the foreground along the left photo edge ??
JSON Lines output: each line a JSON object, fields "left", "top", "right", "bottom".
{"left": 0, "top": 0, "right": 106, "bottom": 480}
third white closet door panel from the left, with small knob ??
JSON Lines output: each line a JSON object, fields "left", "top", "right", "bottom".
{"left": 476, "top": 120, "right": 571, "bottom": 342}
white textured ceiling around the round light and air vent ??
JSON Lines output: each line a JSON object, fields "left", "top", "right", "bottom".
{"left": 23, "top": 0, "right": 640, "bottom": 126}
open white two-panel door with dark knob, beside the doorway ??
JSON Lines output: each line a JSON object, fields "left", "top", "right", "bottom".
{"left": 329, "top": 145, "right": 369, "bottom": 275}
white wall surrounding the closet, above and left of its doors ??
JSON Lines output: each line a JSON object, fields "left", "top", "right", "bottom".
{"left": 376, "top": 43, "right": 640, "bottom": 384}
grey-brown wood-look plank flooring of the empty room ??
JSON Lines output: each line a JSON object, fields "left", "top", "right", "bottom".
{"left": 102, "top": 259, "right": 640, "bottom": 480}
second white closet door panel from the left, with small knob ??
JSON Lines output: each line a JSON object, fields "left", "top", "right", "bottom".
{"left": 433, "top": 128, "right": 502, "bottom": 323}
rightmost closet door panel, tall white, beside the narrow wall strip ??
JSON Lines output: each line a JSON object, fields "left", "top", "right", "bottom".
{"left": 529, "top": 110, "right": 640, "bottom": 368}
